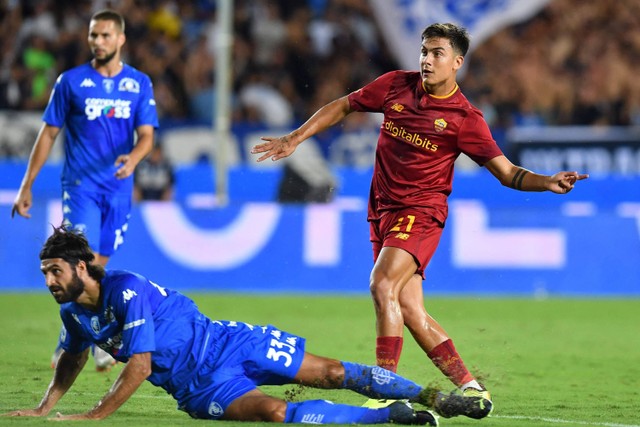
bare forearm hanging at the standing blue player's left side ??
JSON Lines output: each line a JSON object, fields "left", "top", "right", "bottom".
{"left": 11, "top": 123, "right": 60, "bottom": 218}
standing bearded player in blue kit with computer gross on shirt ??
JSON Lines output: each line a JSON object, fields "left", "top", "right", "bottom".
{"left": 11, "top": 10, "right": 158, "bottom": 370}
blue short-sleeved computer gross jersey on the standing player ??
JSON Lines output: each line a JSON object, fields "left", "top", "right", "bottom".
{"left": 43, "top": 63, "right": 158, "bottom": 193}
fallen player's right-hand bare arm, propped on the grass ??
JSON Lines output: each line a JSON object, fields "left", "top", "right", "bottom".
{"left": 55, "top": 353, "right": 151, "bottom": 420}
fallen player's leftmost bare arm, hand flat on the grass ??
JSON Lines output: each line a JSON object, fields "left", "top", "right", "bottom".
{"left": 3, "top": 349, "right": 89, "bottom": 417}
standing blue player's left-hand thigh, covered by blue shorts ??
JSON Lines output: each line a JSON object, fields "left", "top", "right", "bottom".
{"left": 62, "top": 187, "right": 102, "bottom": 252}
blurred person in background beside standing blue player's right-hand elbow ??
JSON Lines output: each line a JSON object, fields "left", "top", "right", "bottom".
{"left": 133, "top": 143, "right": 175, "bottom": 202}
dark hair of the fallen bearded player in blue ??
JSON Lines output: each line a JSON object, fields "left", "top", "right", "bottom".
{"left": 40, "top": 224, "right": 105, "bottom": 282}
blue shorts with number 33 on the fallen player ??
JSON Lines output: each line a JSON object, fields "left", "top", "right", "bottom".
{"left": 174, "top": 321, "right": 305, "bottom": 420}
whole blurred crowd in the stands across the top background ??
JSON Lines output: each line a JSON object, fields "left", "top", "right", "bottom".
{"left": 0, "top": 0, "right": 640, "bottom": 137}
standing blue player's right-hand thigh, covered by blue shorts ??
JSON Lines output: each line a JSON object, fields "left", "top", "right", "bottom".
{"left": 99, "top": 194, "right": 132, "bottom": 256}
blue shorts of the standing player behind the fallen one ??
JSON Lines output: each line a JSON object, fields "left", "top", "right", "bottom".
{"left": 62, "top": 186, "right": 132, "bottom": 256}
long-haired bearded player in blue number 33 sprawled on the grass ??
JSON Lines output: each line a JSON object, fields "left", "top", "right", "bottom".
{"left": 5, "top": 227, "right": 491, "bottom": 425}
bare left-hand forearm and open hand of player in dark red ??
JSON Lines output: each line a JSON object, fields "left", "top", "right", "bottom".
{"left": 251, "top": 96, "right": 353, "bottom": 162}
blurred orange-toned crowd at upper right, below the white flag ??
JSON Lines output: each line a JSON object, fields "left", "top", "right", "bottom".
{"left": 461, "top": 0, "right": 640, "bottom": 127}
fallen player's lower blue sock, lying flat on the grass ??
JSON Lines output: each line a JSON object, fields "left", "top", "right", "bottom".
{"left": 284, "top": 400, "right": 390, "bottom": 424}
